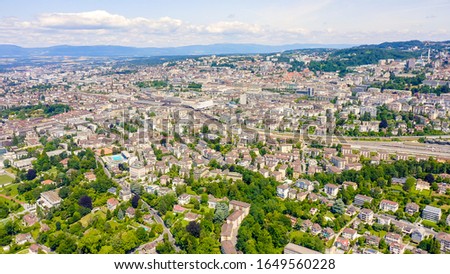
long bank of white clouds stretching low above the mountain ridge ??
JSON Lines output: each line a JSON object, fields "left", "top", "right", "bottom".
{"left": 0, "top": 8, "right": 448, "bottom": 47}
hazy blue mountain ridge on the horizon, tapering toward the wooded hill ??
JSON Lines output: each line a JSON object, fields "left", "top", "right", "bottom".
{"left": 0, "top": 44, "right": 352, "bottom": 57}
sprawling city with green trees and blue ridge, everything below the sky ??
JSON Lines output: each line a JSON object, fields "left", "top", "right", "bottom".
{"left": 0, "top": 1, "right": 450, "bottom": 254}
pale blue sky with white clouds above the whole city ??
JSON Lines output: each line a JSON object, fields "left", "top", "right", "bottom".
{"left": 0, "top": 0, "right": 450, "bottom": 47}
